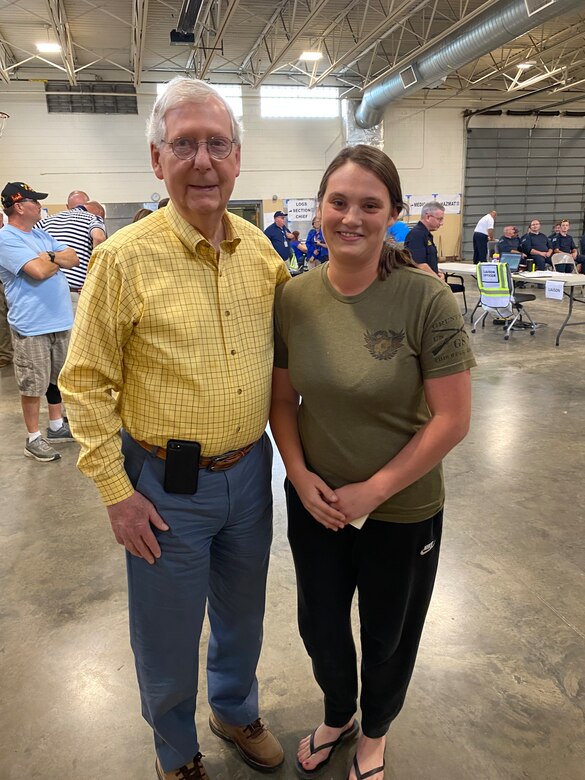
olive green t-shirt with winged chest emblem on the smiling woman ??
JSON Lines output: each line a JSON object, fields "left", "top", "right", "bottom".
{"left": 275, "top": 263, "right": 475, "bottom": 523}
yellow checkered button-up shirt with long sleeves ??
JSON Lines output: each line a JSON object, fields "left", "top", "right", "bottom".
{"left": 59, "top": 203, "right": 289, "bottom": 504}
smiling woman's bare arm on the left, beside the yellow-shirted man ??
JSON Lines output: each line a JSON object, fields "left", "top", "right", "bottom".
{"left": 270, "top": 368, "right": 345, "bottom": 531}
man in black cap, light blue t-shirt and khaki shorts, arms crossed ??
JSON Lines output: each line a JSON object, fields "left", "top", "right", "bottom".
{"left": 0, "top": 182, "right": 79, "bottom": 463}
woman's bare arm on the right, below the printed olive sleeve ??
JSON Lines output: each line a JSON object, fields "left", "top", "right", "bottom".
{"left": 335, "top": 370, "right": 471, "bottom": 522}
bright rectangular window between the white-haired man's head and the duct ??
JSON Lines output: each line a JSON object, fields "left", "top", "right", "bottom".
{"left": 260, "top": 87, "right": 339, "bottom": 119}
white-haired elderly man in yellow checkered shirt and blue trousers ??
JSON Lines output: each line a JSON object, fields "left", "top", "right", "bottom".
{"left": 60, "top": 78, "right": 289, "bottom": 780}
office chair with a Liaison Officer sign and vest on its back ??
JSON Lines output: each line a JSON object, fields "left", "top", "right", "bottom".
{"left": 471, "top": 263, "right": 536, "bottom": 341}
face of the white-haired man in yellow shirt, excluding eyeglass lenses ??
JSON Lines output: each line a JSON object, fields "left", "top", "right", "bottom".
{"left": 150, "top": 97, "right": 240, "bottom": 227}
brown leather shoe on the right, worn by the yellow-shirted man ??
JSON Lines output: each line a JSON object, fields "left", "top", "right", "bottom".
{"left": 209, "top": 712, "right": 284, "bottom": 772}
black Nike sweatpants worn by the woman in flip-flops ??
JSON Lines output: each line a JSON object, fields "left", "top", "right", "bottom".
{"left": 285, "top": 480, "right": 443, "bottom": 739}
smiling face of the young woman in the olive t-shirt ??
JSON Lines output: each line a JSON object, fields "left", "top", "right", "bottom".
{"left": 320, "top": 162, "right": 398, "bottom": 263}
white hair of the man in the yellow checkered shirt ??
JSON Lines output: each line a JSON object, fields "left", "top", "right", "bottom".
{"left": 146, "top": 76, "right": 241, "bottom": 148}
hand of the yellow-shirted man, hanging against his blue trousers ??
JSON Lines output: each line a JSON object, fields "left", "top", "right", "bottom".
{"left": 107, "top": 491, "right": 169, "bottom": 563}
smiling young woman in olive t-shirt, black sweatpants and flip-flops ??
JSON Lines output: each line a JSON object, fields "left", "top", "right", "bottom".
{"left": 270, "top": 145, "right": 475, "bottom": 780}
